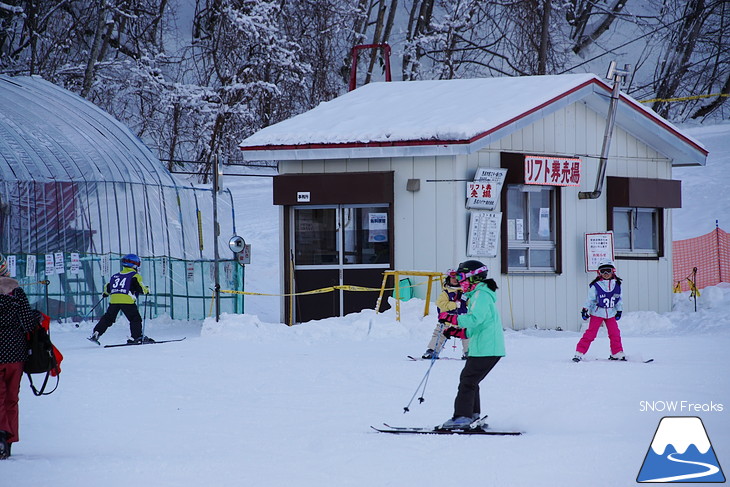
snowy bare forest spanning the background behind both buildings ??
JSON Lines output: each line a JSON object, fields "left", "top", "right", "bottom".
{"left": 0, "top": 0, "right": 730, "bottom": 177}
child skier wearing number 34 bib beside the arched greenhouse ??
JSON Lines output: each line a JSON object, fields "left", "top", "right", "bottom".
{"left": 89, "top": 254, "right": 154, "bottom": 344}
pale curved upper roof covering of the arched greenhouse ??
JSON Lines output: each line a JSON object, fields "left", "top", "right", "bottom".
{"left": 0, "top": 75, "right": 176, "bottom": 186}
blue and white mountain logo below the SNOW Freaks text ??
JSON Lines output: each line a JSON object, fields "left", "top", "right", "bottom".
{"left": 636, "top": 416, "right": 725, "bottom": 483}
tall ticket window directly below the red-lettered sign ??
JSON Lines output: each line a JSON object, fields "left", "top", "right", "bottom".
{"left": 503, "top": 184, "right": 559, "bottom": 272}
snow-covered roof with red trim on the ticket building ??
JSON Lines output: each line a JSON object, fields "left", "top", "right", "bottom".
{"left": 239, "top": 74, "right": 707, "bottom": 165}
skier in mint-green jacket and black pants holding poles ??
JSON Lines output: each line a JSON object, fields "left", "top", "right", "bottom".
{"left": 441, "top": 260, "right": 505, "bottom": 429}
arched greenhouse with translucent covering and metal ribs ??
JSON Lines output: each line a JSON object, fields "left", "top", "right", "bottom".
{"left": 0, "top": 76, "right": 243, "bottom": 321}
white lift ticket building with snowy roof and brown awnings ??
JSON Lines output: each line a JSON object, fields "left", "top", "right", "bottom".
{"left": 240, "top": 74, "right": 707, "bottom": 329}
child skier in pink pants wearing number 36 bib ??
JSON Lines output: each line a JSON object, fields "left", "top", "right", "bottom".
{"left": 573, "top": 261, "right": 626, "bottom": 362}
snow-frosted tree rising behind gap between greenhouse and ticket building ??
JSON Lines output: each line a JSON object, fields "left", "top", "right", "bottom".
{"left": 185, "top": 0, "right": 310, "bottom": 179}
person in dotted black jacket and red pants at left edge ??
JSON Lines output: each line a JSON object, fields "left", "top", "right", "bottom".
{"left": 0, "top": 255, "right": 37, "bottom": 460}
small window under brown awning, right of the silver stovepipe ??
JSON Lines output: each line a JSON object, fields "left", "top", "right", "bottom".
{"left": 613, "top": 207, "right": 660, "bottom": 256}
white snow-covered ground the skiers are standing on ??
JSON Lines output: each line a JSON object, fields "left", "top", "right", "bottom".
{"left": 5, "top": 125, "right": 730, "bottom": 487}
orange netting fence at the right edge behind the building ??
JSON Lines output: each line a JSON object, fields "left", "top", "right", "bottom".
{"left": 672, "top": 227, "right": 730, "bottom": 292}
